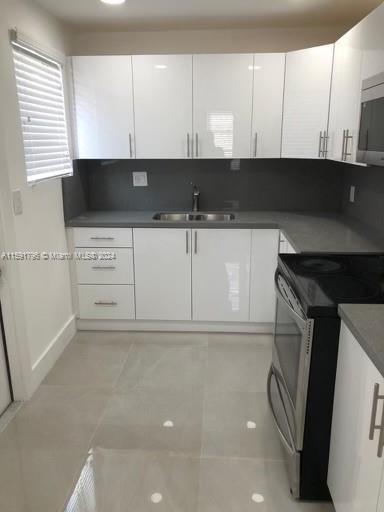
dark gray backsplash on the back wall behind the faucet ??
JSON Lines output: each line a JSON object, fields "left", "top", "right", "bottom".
{"left": 63, "top": 159, "right": 345, "bottom": 219}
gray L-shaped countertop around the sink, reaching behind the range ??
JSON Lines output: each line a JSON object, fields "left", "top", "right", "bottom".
{"left": 66, "top": 211, "right": 384, "bottom": 253}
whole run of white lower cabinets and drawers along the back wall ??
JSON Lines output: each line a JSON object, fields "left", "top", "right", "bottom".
{"left": 73, "top": 228, "right": 279, "bottom": 324}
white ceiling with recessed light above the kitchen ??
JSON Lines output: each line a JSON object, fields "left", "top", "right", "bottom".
{"left": 30, "top": 0, "right": 381, "bottom": 30}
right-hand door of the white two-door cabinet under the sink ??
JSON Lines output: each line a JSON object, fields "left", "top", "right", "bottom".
{"left": 192, "top": 229, "right": 251, "bottom": 322}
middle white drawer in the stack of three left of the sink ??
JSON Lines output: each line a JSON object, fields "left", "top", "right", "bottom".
{"left": 76, "top": 248, "right": 134, "bottom": 284}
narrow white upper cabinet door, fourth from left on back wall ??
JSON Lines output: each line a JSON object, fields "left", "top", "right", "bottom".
{"left": 251, "top": 53, "right": 285, "bottom": 158}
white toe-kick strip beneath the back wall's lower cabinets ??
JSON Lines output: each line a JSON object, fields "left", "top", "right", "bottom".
{"left": 77, "top": 319, "right": 273, "bottom": 334}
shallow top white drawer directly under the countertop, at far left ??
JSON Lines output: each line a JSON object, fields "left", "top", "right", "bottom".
{"left": 73, "top": 228, "right": 132, "bottom": 247}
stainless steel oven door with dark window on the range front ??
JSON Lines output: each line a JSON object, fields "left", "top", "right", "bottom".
{"left": 272, "top": 270, "right": 313, "bottom": 451}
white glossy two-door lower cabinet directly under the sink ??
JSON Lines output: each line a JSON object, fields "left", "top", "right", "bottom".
{"left": 134, "top": 228, "right": 251, "bottom": 322}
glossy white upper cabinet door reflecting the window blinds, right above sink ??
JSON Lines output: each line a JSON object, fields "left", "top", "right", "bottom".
{"left": 193, "top": 54, "right": 253, "bottom": 158}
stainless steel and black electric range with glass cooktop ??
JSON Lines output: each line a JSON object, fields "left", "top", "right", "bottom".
{"left": 268, "top": 254, "right": 384, "bottom": 500}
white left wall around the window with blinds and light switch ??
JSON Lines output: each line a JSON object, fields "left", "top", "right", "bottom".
{"left": 0, "top": 0, "right": 74, "bottom": 399}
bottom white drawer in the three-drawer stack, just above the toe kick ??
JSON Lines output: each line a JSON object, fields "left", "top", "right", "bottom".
{"left": 78, "top": 284, "right": 135, "bottom": 320}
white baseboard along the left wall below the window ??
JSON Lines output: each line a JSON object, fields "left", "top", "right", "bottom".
{"left": 30, "top": 315, "right": 76, "bottom": 395}
